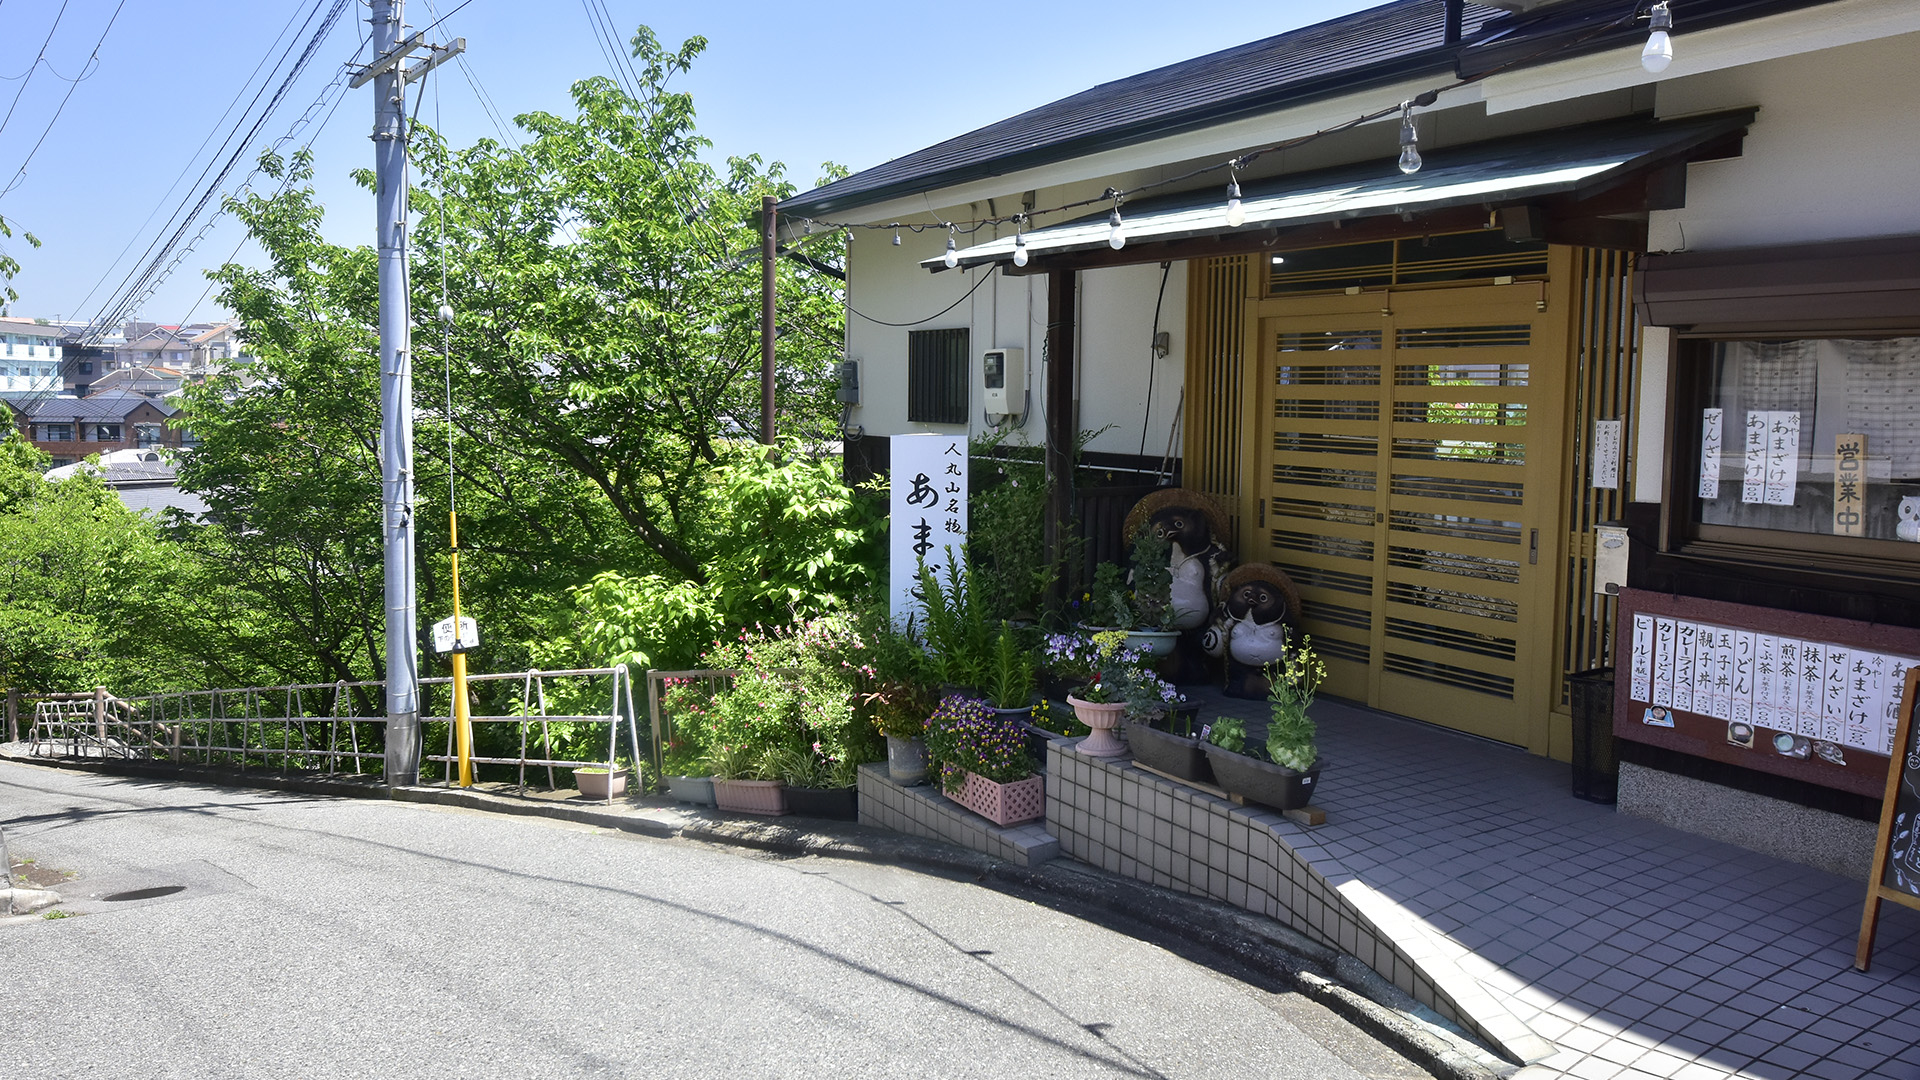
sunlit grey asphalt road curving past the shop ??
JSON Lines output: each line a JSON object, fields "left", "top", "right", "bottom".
{"left": 0, "top": 763, "right": 1425, "bottom": 1080}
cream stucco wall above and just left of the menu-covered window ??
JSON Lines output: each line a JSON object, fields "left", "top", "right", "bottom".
{"left": 1632, "top": 33, "right": 1920, "bottom": 502}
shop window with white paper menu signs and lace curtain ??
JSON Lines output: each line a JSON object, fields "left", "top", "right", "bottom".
{"left": 1674, "top": 334, "right": 1920, "bottom": 573}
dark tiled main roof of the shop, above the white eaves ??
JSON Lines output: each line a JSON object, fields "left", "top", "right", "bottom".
{"left": 780, "top": 0, "right": 1832, "bottom": 215}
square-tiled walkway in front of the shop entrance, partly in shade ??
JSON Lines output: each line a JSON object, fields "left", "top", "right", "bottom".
{"left": 1208, "top": 684, "right": 1920, "bottom": 1080}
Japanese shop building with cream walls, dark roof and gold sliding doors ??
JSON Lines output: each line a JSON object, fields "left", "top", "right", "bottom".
{"left": 781, "top": 0, "right": 1920, "bottom": 857}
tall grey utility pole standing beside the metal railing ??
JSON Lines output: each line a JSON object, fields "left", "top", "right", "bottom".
{"left": 351, "top": 0, "right": 467, "bottom": 786}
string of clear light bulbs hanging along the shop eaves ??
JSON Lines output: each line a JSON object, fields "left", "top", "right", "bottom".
{"left": 801, "top": 0, "right": 1674, "bottom": 247}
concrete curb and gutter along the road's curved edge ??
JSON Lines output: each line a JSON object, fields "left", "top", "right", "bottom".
{"left": 0, "top": 751, "right": 1517, "bottom": 1080}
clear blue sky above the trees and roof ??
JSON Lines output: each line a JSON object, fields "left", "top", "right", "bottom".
{"left": 0, "top": 0, "right": 1373, "bottom": 323}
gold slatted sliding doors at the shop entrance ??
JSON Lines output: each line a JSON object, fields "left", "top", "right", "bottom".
{"left": 1242, "top": 269, "right": 1569, "bottom": 751}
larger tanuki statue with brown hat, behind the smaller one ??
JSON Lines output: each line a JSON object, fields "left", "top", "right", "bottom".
{"left": 1125, "top": 488, "right": 1233, "bottom": 682}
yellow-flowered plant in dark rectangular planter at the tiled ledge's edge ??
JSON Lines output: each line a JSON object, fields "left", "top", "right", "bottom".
{"left": 1208, "top": 634, "right": 1327, "bottom": 811}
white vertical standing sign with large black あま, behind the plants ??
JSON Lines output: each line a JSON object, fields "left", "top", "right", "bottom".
{"left": 887, "top": 434, "right": 968, "bottom": 626}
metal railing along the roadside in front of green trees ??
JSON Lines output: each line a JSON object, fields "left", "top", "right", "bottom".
{"left": 29, "top": 667, "right": 657, "bottom": 792}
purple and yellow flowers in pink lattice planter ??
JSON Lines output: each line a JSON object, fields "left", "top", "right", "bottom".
{"left": 927, "top": 694, "right": 1046, "bottom": 824}
